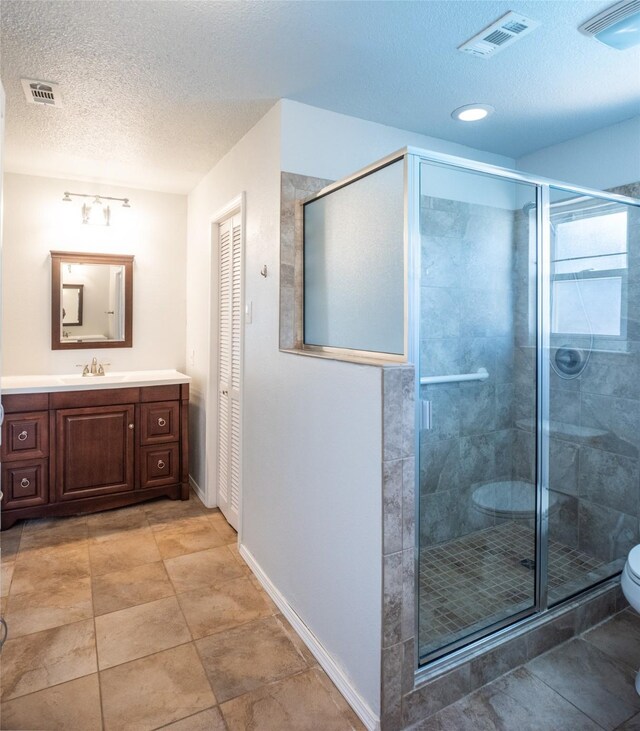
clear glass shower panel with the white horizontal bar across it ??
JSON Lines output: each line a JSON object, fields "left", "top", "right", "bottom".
{"left": 418, "top": 162, "right": 538, "bottom": 659}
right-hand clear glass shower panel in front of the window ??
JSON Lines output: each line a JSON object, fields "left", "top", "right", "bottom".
{"left": 548, "top": 188, "right": 640, "bottom": 605}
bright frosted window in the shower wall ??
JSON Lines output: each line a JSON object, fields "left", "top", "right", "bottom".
{"left": 551, "top": 206, "right": 627, "bottom": 339}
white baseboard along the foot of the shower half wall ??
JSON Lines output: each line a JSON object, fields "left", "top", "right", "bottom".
{"left": 239, "top": 544, "right": 380, "bottom": 731}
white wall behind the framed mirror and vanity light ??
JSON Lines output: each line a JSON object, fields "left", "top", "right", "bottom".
{"left": 2, "top": 173, "right": 186, "bottom": 375}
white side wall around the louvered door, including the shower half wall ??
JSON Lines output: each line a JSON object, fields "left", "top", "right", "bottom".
{"left": 187, "top": 100, "right": 381, "bottom": 713}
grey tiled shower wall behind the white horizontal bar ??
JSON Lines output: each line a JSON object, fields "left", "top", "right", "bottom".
{"left": 420, "top": 196, "right": 515, "bottom": 546}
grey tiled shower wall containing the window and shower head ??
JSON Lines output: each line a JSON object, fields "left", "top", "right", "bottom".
{"left": 514, "top": 183, "right": 640, "bottom": 564}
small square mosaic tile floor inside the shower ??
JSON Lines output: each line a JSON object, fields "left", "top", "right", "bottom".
{"left": 419, "top": 521, "right": 604, "bottom": 655}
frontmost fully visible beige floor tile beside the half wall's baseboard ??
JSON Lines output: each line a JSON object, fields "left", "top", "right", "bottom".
{"left": 196, "top": 617, "right": 307, "bottom": 702}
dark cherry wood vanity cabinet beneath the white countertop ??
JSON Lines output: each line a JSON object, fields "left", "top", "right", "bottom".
{"left": 1, "top": 383, "right": 189, "bottom": 529}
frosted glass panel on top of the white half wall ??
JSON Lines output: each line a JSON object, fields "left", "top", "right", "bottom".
{"left": 304, "top": 160, "right": 404, "bottom": 354}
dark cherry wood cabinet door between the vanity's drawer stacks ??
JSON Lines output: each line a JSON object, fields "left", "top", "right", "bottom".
{"left": 56, "top": 405, "right": 135, "bottom": 500}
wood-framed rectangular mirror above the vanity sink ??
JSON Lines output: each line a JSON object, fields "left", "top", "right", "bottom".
{"left": 51, "top": 251, "right": 133, "bottom": 350}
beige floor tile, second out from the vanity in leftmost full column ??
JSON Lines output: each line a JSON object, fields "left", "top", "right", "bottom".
{"left": 11, "top": 541, "right": 89, "bottom": 594}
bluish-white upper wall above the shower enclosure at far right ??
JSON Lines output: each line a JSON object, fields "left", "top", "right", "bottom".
{"left": 517, "top": 117, "right": 640, "bottom": 190}
